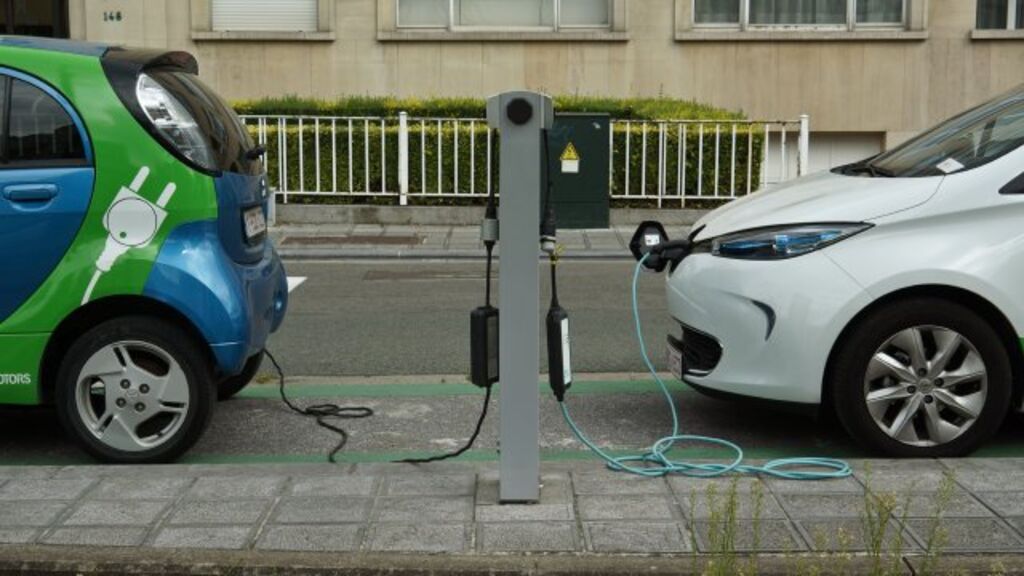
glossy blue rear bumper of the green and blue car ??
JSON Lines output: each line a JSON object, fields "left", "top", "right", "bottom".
{"left": 144, "top": 221, "right": 288, "bottom": 376}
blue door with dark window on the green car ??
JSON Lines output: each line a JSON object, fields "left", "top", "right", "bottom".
{"left": 0, "top": 68, "right": 95, "bottom": 323}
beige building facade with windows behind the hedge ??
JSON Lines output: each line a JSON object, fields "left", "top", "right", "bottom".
{"left": 16, "top": 0, "right": 1024, "bottom": 168}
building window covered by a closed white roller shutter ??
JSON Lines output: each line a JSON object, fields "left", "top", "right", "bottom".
{"left": 212, "top": 0, "right": 318, "bottom": 32}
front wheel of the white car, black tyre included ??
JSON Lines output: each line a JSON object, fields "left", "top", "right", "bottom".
{"left": 833, "top": 298, "right": 1011, "bottom": 457}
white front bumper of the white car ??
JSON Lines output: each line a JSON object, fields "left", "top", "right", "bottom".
{"left": 668, "top": 252, "right": 869, "bottom": 404}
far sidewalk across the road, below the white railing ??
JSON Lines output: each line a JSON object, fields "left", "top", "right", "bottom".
{"left": 270, "top": 224, "right": 659, "bottom": 259}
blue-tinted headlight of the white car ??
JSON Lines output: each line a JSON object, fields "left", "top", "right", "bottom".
{"left": 711, "top": 222, "right": 871, "bottom": 260}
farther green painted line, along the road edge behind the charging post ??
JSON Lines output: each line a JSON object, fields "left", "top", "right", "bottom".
{"left": 239, "top": 380, "right": 695, "bottom": 399}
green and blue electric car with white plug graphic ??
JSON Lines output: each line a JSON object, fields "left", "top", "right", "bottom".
{"left": 0, "top": 37, "right": 288, "bottom": 462}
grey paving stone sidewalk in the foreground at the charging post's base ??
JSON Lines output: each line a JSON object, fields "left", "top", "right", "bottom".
{"left": 0, "top": 459, "right": 1024, "bottom": 556}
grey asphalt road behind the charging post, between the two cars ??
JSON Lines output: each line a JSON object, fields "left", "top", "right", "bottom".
{"left": 269, "top": 260, "right": 678, "bottom": 376}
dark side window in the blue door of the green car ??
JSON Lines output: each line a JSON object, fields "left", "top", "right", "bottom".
{"left": 0, "top": 77, "right": 86, "bottom": 168}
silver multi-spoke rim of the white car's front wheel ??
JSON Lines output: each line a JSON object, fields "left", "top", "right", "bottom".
{"left": 864, "top": 326, "right": 988, "bottom": 446}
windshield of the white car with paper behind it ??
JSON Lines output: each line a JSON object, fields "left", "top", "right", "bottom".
{"left": 862, "top": 85, "right": 1024, "bottom": 177}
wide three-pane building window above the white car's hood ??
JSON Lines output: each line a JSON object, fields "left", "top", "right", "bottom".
{"left": 693, "top": 0, "right": 905, "bottom": 29}
